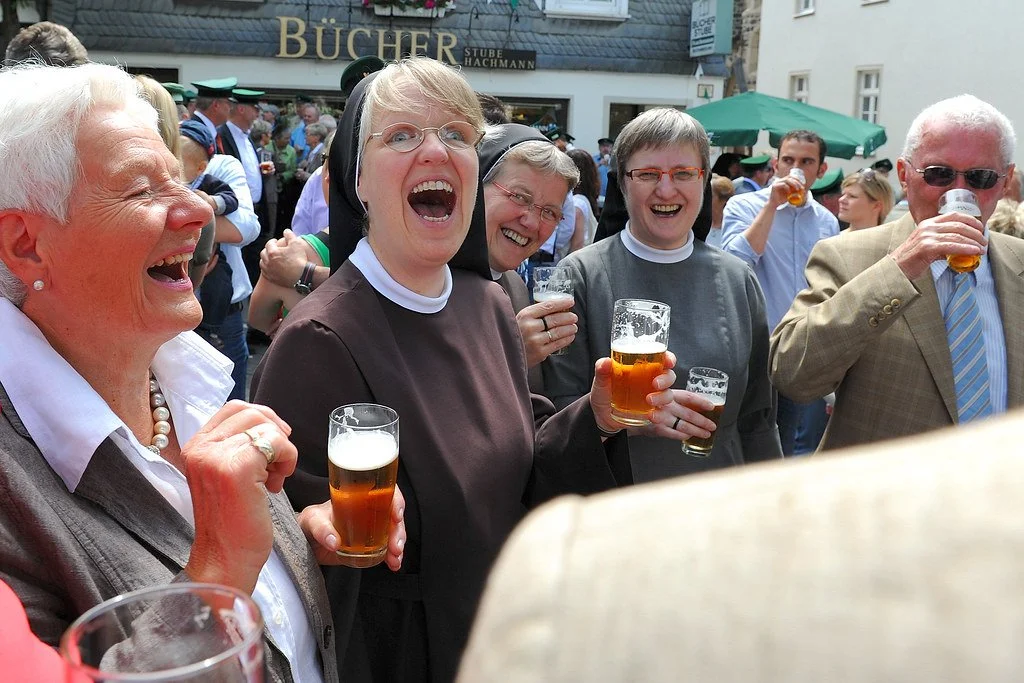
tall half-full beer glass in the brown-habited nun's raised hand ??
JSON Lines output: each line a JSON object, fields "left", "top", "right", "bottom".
{"left": 611, "top": 299, "right": 672, "bottom": 426}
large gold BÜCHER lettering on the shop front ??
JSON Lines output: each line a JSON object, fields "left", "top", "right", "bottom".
{"left": 274, "top": 16, "right": 459, "bottom": 65}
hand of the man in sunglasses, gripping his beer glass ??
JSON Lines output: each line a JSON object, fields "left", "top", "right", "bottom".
{"left": 892, "top": 213, "right": 988, "bottom": 280}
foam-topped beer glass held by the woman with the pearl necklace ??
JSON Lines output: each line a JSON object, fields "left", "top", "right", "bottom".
{"left": 328, "top": 403, "right": 398, "bottom": 568}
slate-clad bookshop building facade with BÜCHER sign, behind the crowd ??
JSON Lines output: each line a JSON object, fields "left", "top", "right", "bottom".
{"left": 49, "top": 0, "right": 725, "bottom": 152}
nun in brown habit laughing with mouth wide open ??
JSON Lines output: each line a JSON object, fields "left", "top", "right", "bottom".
{"left": 253, "top": 58, "right": 696, "bottom": 683}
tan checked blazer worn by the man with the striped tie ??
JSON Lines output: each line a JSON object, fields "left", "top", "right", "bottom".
{"left": 770, "top": 214, "right": 1024, "bottom": 450}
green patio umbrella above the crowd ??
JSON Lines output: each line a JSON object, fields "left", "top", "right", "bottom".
{"left": 686, "top": 92, "right": 886, "bottom": 159}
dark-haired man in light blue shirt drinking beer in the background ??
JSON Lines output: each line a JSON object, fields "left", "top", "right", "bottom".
{"left": 722, "top": 130, "right": 839, "bottom": 456}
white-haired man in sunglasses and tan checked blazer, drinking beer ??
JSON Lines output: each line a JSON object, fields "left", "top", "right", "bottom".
{"left": 770, "top": 95, "right": 1024, "bottom": 456}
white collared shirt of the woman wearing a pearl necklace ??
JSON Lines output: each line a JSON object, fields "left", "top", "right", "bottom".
{"left": 0, "top": 299, "right": 324, "bottom": 681}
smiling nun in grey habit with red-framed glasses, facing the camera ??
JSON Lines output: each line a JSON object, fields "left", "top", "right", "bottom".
{"left": 545, "top": 109, "right": 782, "bottom": 483}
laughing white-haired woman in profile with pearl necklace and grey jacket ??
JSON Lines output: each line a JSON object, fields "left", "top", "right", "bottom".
{"left": 0, "top": 65, "right": 403, "bottom": 681}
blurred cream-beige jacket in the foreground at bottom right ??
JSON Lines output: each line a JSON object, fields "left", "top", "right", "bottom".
{"left": 458, "top": 412, "right": 1024, "bottom": 683}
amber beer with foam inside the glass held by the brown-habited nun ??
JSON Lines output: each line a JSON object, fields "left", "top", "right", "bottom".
{"left": 611, "top": 341, "right": 668, "bottom": 426}
